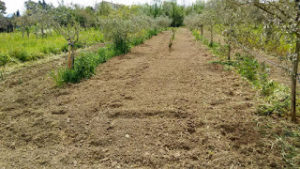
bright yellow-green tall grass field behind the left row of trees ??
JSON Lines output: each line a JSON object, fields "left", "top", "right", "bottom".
{"left": 0, "top": 29, "right": 104, "bottom": 66}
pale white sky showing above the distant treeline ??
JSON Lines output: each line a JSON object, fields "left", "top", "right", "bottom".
{"left": 2, "top": 0, "right": 196, "bottom": 14}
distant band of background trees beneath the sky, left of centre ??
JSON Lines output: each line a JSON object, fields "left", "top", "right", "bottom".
{"left": 0, "top": 0, "right": 189, "bottom": 37}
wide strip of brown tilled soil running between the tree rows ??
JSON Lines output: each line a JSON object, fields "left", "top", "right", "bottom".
{"left": 0, "top": 29, "right": 284, "bottom": 168}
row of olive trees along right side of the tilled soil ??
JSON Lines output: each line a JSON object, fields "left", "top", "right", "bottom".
{"left": 185, "top": 0, "right": 300, "bottom": 121}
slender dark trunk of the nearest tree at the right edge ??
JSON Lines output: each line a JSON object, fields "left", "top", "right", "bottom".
{"left": 291, "top": 35, "right": 300, "bottom": 122}
